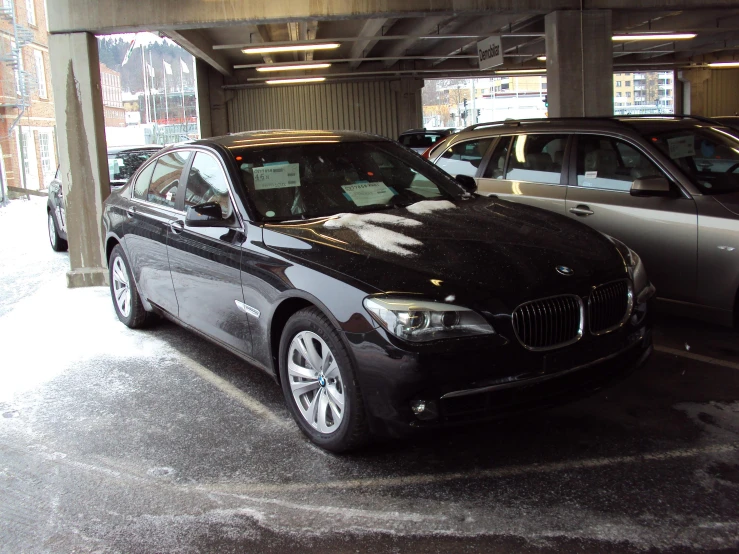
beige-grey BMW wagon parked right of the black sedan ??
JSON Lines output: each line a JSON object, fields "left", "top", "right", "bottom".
{"left": 430, "top": 116, "right": 739, "bottom": 325}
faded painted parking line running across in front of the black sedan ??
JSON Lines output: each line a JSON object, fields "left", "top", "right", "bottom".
{"left": 208, "top": 443, "right": 739, "bottom": 495}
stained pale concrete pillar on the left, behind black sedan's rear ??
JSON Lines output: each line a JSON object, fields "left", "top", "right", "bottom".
{"left": 49, "top": 33, "right": 110, "bottom": 287}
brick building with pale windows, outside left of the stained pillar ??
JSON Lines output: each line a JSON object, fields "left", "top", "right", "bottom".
{"left": 0, "top": 0, "right": 57, "bottom": 190}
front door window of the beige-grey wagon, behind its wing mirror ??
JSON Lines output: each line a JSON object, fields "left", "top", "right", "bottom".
{"left": 577, "top": 135, "right": 664, "bottom": 191}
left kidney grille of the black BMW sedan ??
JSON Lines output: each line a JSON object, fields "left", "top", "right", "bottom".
{"left": 511, "top": 295, "right": 584, "bottom": 350}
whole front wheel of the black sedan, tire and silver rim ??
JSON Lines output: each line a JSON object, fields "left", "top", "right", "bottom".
{"left": 280, "top": 308, "right": 369, "bottom": 453}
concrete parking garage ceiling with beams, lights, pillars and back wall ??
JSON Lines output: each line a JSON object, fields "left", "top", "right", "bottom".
{"left": 48, "top": 0, "right": 739, "bottom": 286}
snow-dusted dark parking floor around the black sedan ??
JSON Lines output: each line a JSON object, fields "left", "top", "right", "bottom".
{"left": 0, "top": 196, "right": 739, "bottom": 553}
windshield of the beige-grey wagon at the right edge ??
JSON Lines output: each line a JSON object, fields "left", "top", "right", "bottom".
{"left": 647, "top": 127, "right": 739, "bottom": 194}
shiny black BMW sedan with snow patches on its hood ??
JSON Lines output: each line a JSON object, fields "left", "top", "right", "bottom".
{"left": 103, "top": 131, "right": 654, "bottom": 452}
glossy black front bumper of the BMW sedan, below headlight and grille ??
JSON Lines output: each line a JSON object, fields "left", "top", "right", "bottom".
{"left": 346, "top": 310, "right": 652, "bottom": 436}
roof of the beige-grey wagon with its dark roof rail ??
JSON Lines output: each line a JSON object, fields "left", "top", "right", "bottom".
{"left": 460, "top": 115, "right": 732, "bottom": 136}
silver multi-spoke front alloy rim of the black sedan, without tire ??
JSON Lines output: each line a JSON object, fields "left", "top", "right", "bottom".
{"left": 287, "top": 331, "right": 345, "bottom": 434}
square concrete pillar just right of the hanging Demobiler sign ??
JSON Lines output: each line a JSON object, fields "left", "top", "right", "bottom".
{"left": 544, "top": 10, "right": 613, "bottom": 117}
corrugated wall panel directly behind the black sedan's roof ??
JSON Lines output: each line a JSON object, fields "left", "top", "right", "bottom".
{"left": 228, "top": 81, "right": 398, "bottom": 139}
